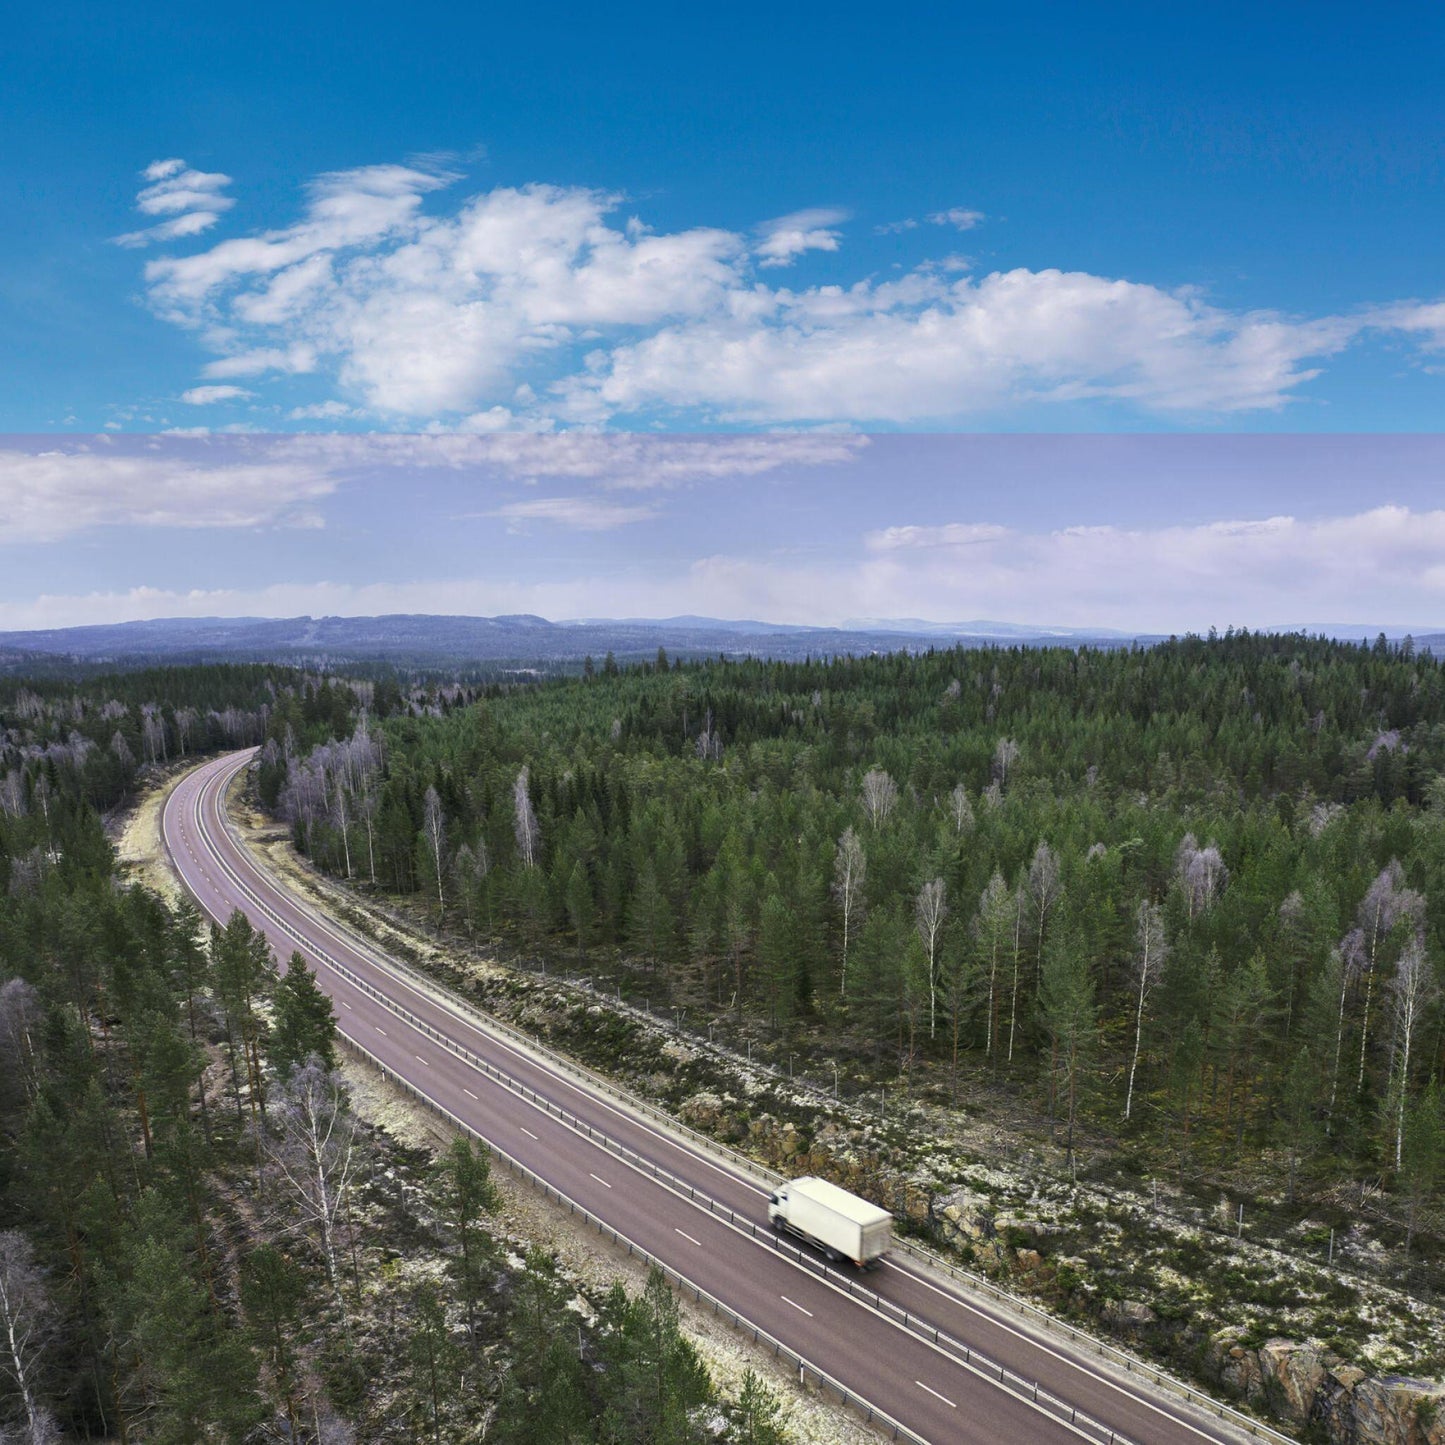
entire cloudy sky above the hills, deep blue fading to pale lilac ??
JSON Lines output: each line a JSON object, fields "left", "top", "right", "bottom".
{"left": 0, "top": 3, "right": 1445, "bottom": 627}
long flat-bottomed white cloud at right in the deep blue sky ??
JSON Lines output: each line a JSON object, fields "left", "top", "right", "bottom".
{"left": 566, "top": 270, "right": 1358, "bottom": 423}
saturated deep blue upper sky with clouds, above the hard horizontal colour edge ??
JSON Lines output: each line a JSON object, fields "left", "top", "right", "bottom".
{"left": 8, "top": 3, "right": 1445, "bottom": 432}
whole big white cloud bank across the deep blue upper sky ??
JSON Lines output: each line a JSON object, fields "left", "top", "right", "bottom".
{"left": 127, "top": 160, "right": 1445, "bottom": 434}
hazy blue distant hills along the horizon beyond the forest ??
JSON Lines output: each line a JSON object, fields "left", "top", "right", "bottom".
{"left": 0, "top": 613, "right": 1160, "bottom": 672}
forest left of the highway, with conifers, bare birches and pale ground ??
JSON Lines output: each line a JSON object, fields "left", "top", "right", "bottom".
{"left": 0, "top": 668, "right": 783, "bottom": 1445}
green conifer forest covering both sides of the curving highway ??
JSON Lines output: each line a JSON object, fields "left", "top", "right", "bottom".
{"left": 8, "top": 634, "right": 1445, "bottom": 1441}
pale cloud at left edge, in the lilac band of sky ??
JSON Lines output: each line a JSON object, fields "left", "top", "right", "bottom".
{"left": 0, "top": 444, "right": 337, "bottom": 545}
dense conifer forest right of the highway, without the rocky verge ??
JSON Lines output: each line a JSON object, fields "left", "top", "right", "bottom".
{"left": 278, "top": 633, "right": 1445, "bottom": 1251}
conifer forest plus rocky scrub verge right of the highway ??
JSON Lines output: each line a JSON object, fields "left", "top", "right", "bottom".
{"left": 257, "top": 634, "right": 1445, "bottom": 1433}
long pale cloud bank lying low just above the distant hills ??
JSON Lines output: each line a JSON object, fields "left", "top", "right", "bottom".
{"left": 11, "top": 499, "right": 1445, "bottom": 631}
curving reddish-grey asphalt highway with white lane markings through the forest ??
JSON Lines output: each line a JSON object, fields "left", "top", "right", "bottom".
{"left": 162, "top": 750, "right": 1279, "bottom": 1445}
